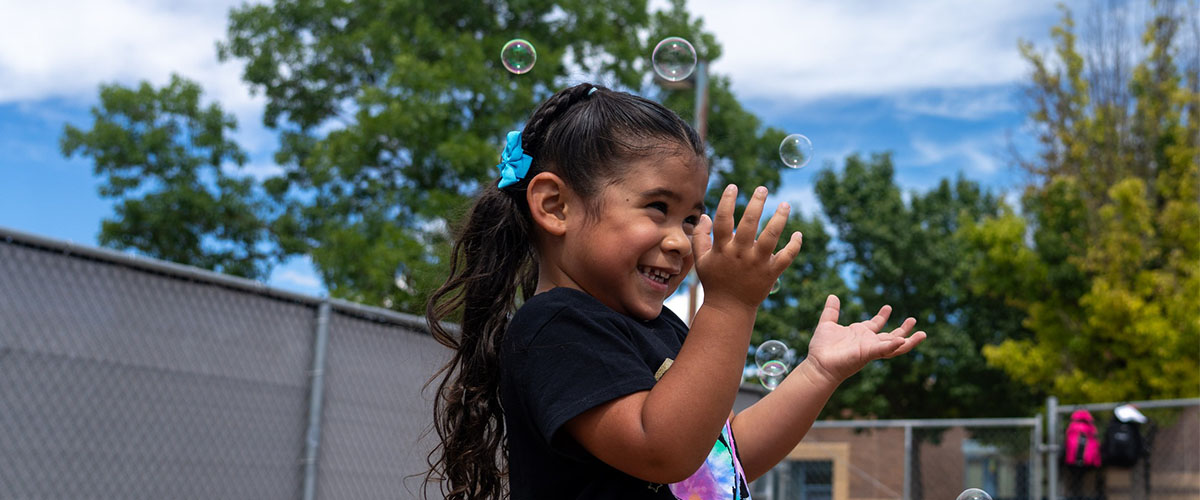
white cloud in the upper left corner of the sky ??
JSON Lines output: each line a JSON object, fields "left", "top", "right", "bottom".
{"left": 0, "top": 0, "right": 263, "bottom": 118}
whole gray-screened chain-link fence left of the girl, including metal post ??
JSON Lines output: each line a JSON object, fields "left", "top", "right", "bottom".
{"left": 0, "top": 230, "right": 446, "bottom": 499}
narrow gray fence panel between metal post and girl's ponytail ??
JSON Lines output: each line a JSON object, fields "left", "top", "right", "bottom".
{"left": 317, "top": 314, "right": 449, "bottom": 499}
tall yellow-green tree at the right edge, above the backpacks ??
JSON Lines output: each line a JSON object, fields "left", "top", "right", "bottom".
{"left": 960, "top": 2, "right": 1200, "bottom": 403}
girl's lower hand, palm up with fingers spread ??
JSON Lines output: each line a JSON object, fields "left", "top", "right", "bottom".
{"left": 809, "top": 295, "right": 925, "bottom": 382}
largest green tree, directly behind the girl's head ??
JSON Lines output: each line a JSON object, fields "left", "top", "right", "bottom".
{"left": 218, "top": 0, "right": 781, "bottom": 311}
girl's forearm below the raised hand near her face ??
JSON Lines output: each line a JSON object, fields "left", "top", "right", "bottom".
{"left": 642, "top": 298, "right": 755, "bottom": 474}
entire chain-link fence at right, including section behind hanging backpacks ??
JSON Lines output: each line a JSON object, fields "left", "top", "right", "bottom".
{"left": 752, "top": 398, "right": 1200, "bottom": 500}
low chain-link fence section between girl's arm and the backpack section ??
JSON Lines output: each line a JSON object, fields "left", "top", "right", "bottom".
{"left": 755, "top": 418, "right": 1040, "bottom": 500}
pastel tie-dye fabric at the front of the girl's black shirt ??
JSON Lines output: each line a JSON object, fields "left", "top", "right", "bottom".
{"left": 668, "top": 421, "right": 750, "bottom": 500}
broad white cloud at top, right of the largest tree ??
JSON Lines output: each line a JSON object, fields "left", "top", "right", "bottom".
{"left": 672, "top": 0, "right": 1079, "bottom": 102}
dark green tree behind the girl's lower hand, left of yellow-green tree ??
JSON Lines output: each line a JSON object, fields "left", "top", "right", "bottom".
{"left": 816, "top": 153, "right": 1036, "bottom": 418}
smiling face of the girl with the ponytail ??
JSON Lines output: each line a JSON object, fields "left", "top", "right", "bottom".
{"left": 562, "top": 149, "right": 708, "bottom": 320}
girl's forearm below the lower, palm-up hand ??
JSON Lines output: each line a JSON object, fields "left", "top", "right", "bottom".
{"left": 732, "top": 360, "right": 840, "bottom": 481}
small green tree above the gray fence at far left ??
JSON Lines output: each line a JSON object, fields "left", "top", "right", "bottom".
{"left": 61, "top": 76, "right": 274, "bottom": 278}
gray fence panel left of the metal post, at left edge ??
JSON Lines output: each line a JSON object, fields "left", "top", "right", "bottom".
{"left": 0, "top": 241, "right": 313, "bottom": 499}
